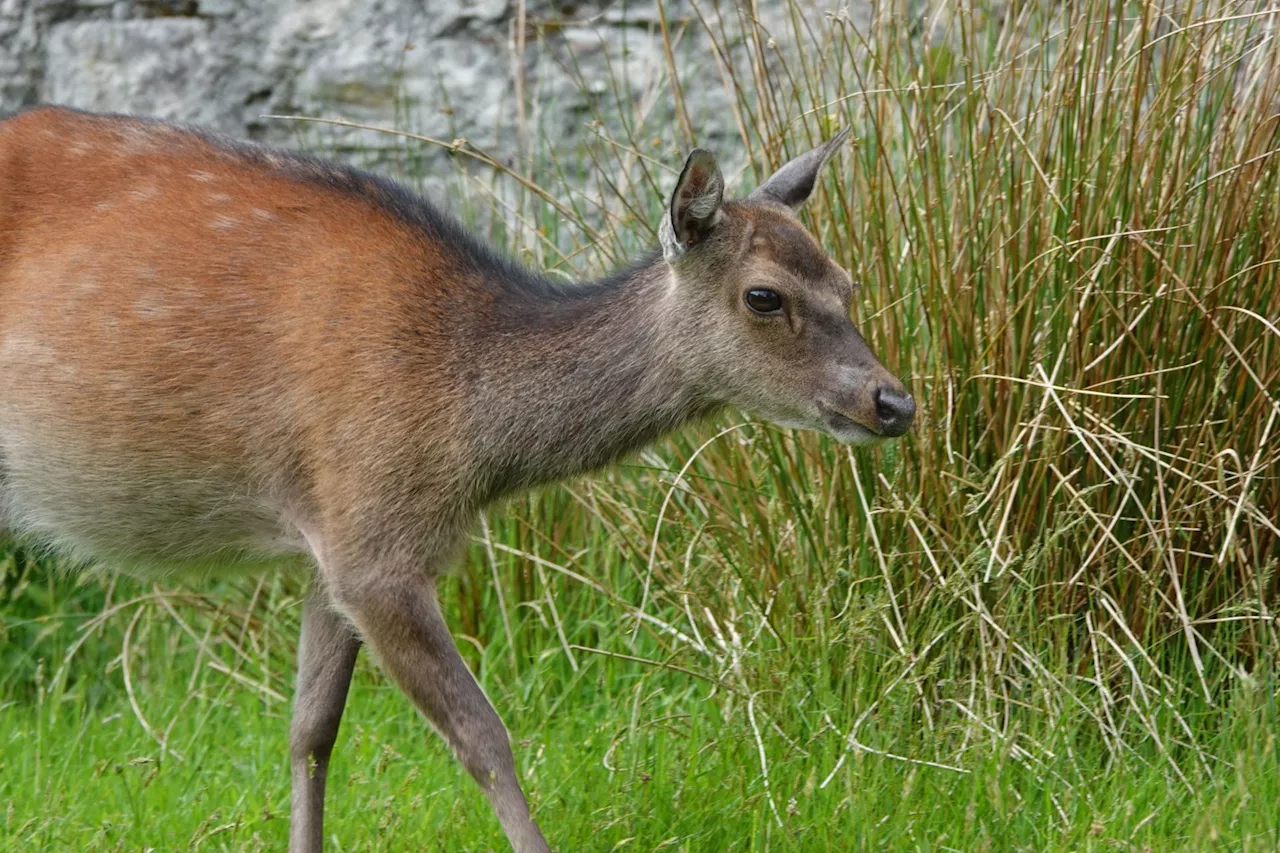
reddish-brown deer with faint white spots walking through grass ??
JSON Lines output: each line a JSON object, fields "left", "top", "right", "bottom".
{"left": 0, "top": 105, "right": 915, "bottom": 853}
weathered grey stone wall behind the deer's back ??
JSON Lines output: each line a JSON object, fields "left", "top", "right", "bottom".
{"left": 0, "top": 0, "right": 869, "bottom": 160}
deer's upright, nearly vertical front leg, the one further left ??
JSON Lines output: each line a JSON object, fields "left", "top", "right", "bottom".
{"left": 289, "top": 584, "right": 360, "bottom": 853}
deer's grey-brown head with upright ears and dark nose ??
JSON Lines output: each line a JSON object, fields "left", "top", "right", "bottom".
{"left": 659, "top": 131, "right": 915, "bottom": 443}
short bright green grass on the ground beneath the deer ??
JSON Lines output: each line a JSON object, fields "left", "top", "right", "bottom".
{"left": 0, "top": 550, "right": 1280, "bottom": 850}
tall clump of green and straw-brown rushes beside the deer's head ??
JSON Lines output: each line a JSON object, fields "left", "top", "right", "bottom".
{"left": 455, "top": 3, "right": 1280, "bottom": 758}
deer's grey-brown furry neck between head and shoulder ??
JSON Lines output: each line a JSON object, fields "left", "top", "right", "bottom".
{"left": 471, "top": 257, "right": 713, "bottom": 502}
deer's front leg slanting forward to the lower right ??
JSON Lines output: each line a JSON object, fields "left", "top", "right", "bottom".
{"left": 335, "top": 560, "right": 550, "bottom": 853}
